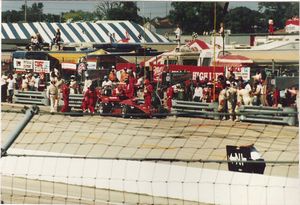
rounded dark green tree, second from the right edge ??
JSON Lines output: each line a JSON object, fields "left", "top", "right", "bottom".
{"left": 225, "top": 7, "right": 265, "bottom": 33}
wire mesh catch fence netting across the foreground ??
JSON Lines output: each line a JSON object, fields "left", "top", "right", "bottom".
{"left": 1, "top": 109, "right": 300, "bottom": 204}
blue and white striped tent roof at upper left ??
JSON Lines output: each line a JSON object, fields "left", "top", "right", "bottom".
{"left": 1, "top": 21, "right": 169, "bottom": 43}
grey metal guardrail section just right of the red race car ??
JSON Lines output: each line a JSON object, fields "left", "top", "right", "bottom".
{"left": 172, "top": 100, "right": 219, "bottom": 119}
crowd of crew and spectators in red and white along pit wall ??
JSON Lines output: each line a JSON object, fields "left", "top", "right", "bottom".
{"left": 1, "top": 66, "right": 298, "bottom": 117}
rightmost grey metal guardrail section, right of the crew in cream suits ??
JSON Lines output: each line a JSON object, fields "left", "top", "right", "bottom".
{"left": 238, "top": 106, "right": 298, "bottom": 126}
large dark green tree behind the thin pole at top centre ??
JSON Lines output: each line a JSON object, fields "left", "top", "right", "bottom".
{"left": 169, "top": 2, "right": 224, "bottom": 34}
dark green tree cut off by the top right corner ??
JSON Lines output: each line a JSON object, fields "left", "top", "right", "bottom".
{"left": 258, "top": 2, "right": 299, "bottom": 29}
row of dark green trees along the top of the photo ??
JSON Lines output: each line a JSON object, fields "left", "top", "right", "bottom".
{"left": 2, "top": 1, "right": 299, "bottom": 34}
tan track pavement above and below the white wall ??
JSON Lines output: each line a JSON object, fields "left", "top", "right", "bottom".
{"left": 1, "top": 104, "right": 299, "bottom": 204}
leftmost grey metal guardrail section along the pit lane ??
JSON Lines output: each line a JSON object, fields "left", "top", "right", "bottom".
{"left": 13, "top": 90, "right": 50, "bottom": 105}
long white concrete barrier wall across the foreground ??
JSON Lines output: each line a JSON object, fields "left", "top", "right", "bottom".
{"left": 1, "top": 149, "right": 300, "bottom": 205}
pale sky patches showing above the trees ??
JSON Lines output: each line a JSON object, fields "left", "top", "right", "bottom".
{"left": 2, "top": 0, "right": 257, "bottom": 18}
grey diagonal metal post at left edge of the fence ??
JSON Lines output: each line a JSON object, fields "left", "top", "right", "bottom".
{"left": 1, "top": 105, "right": 39, "bottom": 157}
